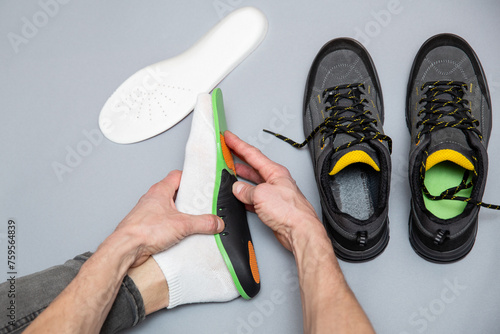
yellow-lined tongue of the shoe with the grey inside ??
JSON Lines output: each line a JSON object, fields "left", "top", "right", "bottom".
{"left": 328, "top": 144, "right": 380, "bottom": 175}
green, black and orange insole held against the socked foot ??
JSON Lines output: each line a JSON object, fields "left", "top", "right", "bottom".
{"left": 212, "top": 88, "right": 260, "bottom": 299}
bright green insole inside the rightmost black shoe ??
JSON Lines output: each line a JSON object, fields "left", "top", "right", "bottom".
{"left": 422, "top": 161, "right": 472, "bottom": 219}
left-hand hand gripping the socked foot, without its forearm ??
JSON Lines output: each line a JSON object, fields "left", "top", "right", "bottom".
{"left": 110, "top": 170, "right": 224, "bottom": 267}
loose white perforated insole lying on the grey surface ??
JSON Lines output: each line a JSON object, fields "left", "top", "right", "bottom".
{"left": 99, "top": 7, "right": 268, "bottom": 144}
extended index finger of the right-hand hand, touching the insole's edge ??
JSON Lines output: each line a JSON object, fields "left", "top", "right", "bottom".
{"left": 224, "top": 131, "right": 290, "bottom": 181}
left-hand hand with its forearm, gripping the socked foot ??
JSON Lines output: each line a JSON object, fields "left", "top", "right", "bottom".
{"left": 25, "top": 171, "right": 224, "bottom": 333}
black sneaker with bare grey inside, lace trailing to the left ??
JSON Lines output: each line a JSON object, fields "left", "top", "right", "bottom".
{"left": 266, "top": 38, "right": 392, "bottom": 261}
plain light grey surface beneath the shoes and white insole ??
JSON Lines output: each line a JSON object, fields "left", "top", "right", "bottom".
{"left": 0, "top": 0, "right": 500, "bottom": 333}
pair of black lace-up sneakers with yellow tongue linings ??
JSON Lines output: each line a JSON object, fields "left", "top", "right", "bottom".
{"left": 268, "top": 34, "right": 498, "bottom": 262}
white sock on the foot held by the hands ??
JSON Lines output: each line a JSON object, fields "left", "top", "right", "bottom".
{"left": 153, "top": 94, "right": 239, "bottom": 309}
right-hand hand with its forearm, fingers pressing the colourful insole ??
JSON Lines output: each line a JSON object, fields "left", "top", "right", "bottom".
{"left": 224, "top": 131, "right": 374, "bottom": 333}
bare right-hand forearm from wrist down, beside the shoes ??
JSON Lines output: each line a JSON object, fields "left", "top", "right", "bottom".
{"left": 292, "top": 221, "right": 374, "bottom": 333}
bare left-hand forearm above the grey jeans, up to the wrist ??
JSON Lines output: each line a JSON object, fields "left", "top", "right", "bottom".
{"left": 25, "top": 235, "right": 139, "bottom": 333}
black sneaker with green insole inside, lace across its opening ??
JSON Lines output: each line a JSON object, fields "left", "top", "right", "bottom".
{"left": 406, "top": 34, "right": 498, "bottom": 262}
